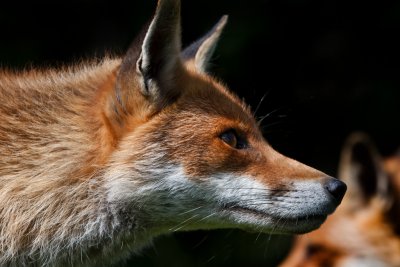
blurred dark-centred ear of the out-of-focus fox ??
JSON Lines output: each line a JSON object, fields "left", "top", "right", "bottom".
{"left": 339, "top": 133, "right": 390, "bottom": 207}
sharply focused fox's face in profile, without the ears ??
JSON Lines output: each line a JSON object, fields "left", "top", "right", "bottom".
{"left": 104, "top": 75, "right": 343, "bottom": 237}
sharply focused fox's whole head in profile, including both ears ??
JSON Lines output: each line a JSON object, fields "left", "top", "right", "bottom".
{"left": 98, "top": 0, "right": 346, "bottom": 243}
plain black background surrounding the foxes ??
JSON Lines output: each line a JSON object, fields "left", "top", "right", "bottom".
{"left": 0, "top": 0, "right": 400, "bottom": 266}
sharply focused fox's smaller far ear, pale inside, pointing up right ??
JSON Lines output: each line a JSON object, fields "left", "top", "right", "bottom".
{"left": 182, "top": 15, "right": 228, "bottom": 73}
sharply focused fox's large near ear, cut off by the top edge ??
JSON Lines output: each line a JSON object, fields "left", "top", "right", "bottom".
{"left": 116, "top": 0, "right": 182, "bottom": 111}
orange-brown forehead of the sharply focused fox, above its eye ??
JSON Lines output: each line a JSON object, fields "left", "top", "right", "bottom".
{"left": 160, "top": 69, "right": 263, "bottom": 148}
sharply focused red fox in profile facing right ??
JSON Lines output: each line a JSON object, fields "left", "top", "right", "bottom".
{"left": 0, "top": 0, "right": 346, "bottom": 266}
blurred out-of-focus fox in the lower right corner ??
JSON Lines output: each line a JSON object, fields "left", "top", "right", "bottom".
{"left": 281, "top": 133, "right": 400, "bottom": 267}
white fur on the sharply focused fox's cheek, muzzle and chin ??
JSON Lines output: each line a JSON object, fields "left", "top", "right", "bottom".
{"left": 105, "top": 145, "right": 335, "bottom": 243}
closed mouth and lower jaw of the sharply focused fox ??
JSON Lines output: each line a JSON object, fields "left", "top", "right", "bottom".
{"left": 224, "top": 205, "right": 328, "bottom": 234}
